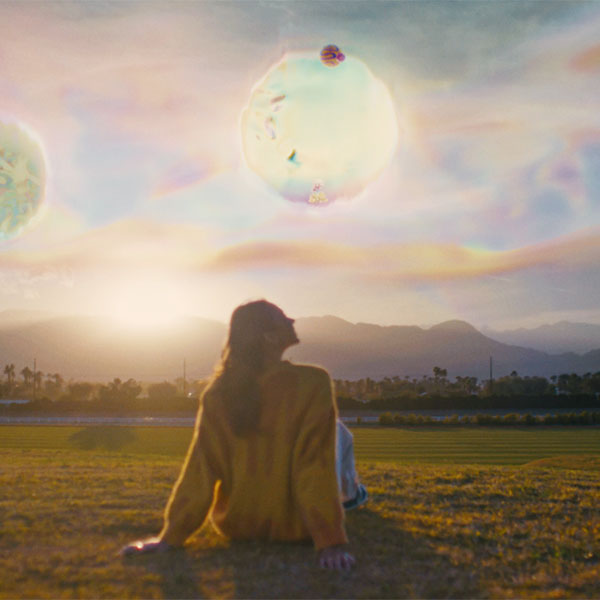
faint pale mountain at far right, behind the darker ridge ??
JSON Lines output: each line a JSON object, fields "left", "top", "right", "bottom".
{"left": 481, "top": 321, "right": 600, "bottom": 354}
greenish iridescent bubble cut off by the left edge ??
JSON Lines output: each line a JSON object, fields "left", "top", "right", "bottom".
{"left": 0, "top": 120, "right": 46, "bottom": 241}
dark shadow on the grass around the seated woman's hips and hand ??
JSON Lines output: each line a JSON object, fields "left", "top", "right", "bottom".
{"left": 120, "top": 506, "right": 486, "bottom": 598}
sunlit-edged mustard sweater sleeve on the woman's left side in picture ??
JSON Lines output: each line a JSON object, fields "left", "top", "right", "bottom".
{"left": 159, "top": 400, "right": 221, "bottom": 546}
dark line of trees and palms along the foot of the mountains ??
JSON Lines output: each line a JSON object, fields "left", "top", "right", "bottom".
{"left": 0, "top": 363, "right": 600, "bottom": 412}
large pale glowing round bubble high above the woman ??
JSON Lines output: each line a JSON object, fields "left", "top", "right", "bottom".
{"left": 240, "top": 53, "right": 398, "bottom": 206}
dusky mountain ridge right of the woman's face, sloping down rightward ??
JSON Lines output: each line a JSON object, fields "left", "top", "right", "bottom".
{"left": 288, "top": 316, "right": 600, "bottom": 379}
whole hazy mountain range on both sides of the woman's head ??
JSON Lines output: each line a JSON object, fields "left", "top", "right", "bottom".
{"left": 0, "top": 313, "right": 600, "bottom": 381}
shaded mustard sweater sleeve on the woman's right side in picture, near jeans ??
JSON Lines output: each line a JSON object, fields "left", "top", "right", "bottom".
{"left": 292, "top": 370, "right": 348, "bottom": 550}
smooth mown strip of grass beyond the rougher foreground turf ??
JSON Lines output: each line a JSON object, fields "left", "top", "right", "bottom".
{"left": 0, "top": 425, "right": 600, "bottom": 465}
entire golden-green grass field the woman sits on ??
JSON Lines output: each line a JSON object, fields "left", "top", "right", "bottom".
{"left": 0, "top": 426, "right": 600, "bottom": 598}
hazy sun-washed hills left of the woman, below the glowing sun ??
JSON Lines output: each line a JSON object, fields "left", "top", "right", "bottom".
{"left": 0, "top": 313, "right": 226, "bottom": 381}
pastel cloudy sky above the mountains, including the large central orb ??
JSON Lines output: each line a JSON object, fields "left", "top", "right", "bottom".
{"left": 0, "top": 0, "right": 600, "bottom": 329}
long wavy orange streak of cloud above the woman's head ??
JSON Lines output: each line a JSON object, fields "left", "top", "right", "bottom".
{"left": 204, "top": 226, "right": 600, "bottom": 282}
